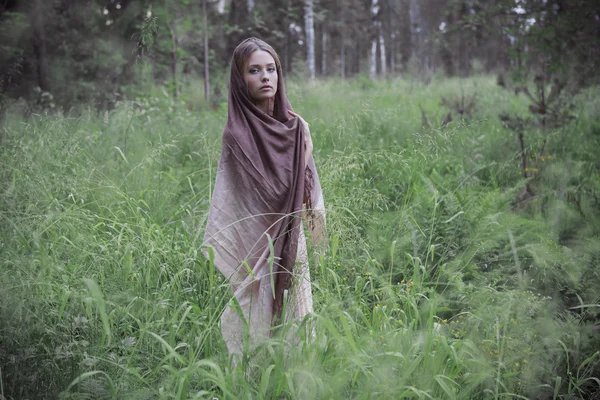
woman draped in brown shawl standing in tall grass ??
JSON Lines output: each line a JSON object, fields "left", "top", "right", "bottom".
{"left": 204, "top": 38, "right": 325, "bottom": 363}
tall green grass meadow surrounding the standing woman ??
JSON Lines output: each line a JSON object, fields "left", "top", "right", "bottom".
{"left": 0, "top": 76, "right": 600, "bottom": 400}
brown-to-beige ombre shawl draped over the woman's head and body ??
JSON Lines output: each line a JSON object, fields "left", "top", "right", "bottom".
{"left": 204, "top": 38, "right": 316, "bottom": 315}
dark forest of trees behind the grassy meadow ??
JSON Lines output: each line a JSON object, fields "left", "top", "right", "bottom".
{"left": 0, "top": 0, "right": 600, "bottom": 109}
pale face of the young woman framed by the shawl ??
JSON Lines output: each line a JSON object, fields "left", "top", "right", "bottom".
{"left": 244, "top": 50, "right": 278, "bottom": 106}
